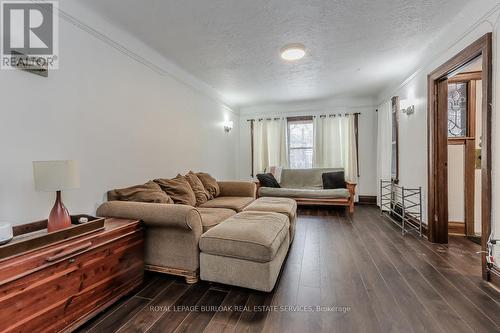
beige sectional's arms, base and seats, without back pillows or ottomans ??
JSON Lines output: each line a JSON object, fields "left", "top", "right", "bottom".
{"left": 97, "top": 182, "right": 256, "bottom": 283}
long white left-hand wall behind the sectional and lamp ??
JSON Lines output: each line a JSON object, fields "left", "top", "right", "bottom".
{"left": 0, "top": 0, "right": 239, "bottom": 223}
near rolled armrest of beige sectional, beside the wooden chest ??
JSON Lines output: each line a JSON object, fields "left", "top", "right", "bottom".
{"left": 97, "top": 201, "right": 202, "bottom": 234}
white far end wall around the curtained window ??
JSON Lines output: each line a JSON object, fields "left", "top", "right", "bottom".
{"left": 238, "top": 98, "right": 377, "bottom": 195}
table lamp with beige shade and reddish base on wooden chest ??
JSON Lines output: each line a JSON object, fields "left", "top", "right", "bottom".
{"left": 33, "top": 161, "right": 80, "bottom": 232}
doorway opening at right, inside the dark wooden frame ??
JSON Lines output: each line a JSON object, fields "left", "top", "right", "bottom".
{"left": 447, "top": 56, "right": 483, "bottom": 244}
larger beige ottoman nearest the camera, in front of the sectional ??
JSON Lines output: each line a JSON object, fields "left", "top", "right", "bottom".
{"left": 200, "top": 212, "right": 290, "bottom": 292}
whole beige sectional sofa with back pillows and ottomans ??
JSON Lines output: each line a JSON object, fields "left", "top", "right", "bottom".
{"left": 97, "top": 172, "right": 297, "bottom": 291}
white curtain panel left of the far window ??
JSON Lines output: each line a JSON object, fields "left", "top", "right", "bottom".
{"left": 254, "top": 118, "right": 288, "bottom": 173}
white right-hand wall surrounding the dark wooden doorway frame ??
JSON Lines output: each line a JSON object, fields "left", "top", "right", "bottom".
{"left": 377, "top": 0, "right": 500, "bottom": 226}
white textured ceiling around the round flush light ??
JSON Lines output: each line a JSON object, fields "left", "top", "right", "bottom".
{"left": 82, "top": 0, "right": 468, "bottom": 106}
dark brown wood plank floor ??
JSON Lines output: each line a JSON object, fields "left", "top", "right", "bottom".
{"left": 79, "top": 206, "right": 500, "bottom": 333}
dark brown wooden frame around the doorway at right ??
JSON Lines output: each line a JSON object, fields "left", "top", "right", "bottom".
{"left": 427, "top": 33, "right": 492, "bottom": 279}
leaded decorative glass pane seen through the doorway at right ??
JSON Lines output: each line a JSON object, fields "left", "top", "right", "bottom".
{"left": 448, "top": 82, "right": 467, "bottom": 138}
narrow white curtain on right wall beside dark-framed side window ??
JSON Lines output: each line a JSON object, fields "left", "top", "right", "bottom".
{"left": 377, "top": 101, "right": 392, "bottom": 206}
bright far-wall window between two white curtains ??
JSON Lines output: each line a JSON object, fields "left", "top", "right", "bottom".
{"left": 288, "top": 117, "right": 314, "bottom": 169}
